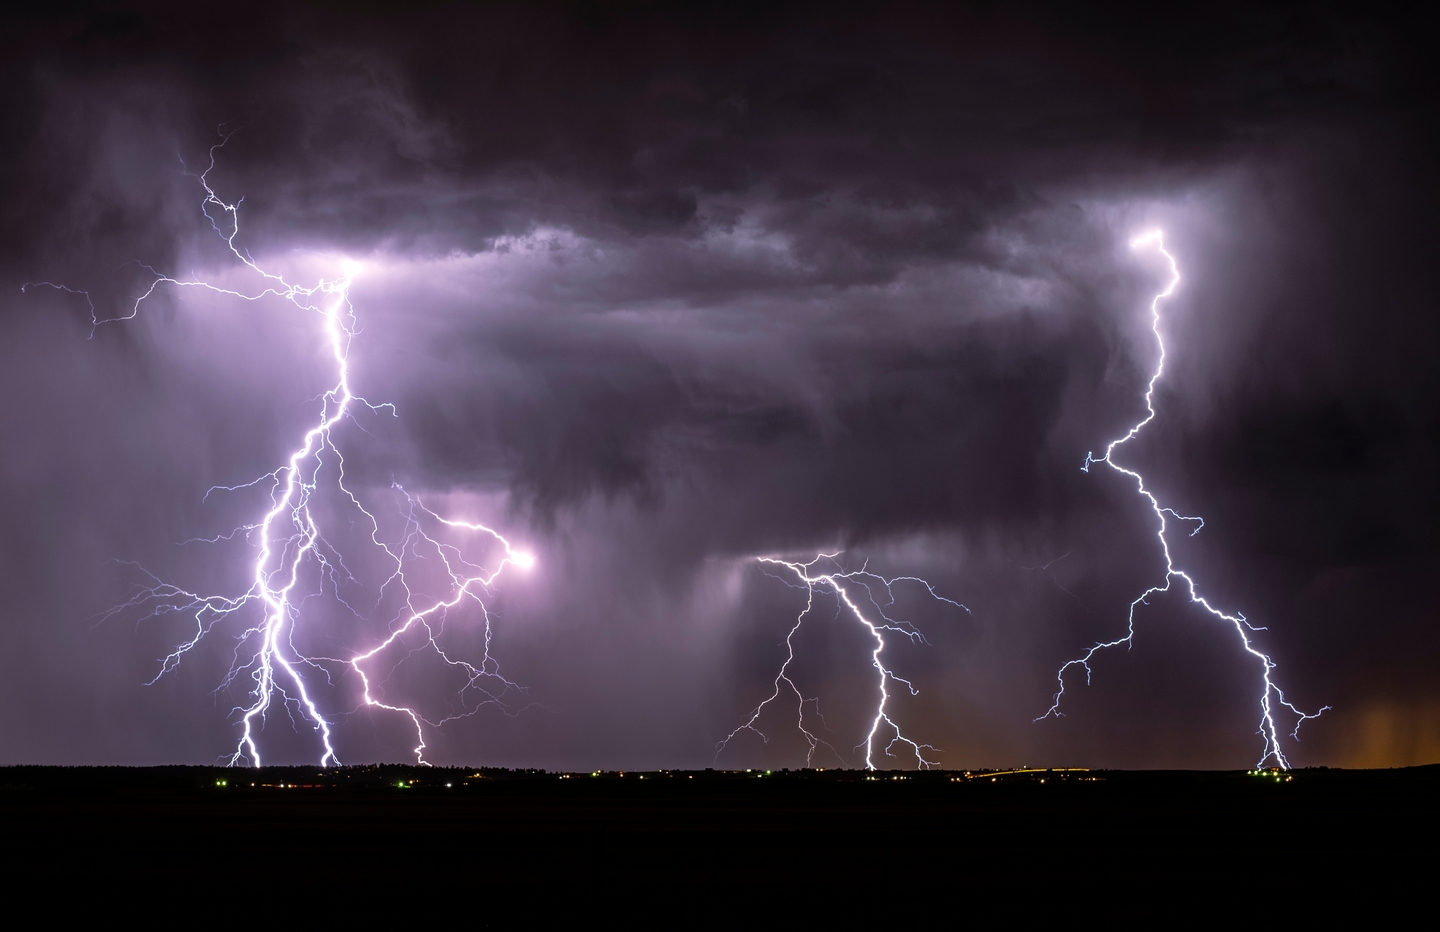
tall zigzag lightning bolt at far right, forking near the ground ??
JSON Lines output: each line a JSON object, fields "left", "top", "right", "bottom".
{"left": 1035, "top": 230, "right": 1329, "bottom": 768}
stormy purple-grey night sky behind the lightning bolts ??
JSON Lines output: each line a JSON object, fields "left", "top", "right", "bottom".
{"left": 0, "top": 1, "right": 1440, "bottom": 769}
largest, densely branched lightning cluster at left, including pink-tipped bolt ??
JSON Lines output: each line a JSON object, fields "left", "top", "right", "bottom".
{"left": 30, "top": 135, "right": 534, "bottom": 766}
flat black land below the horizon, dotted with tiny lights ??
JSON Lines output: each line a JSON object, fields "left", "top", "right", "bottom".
{"left": 0, "top": 766, "right": 1440, "bottom": 926}
